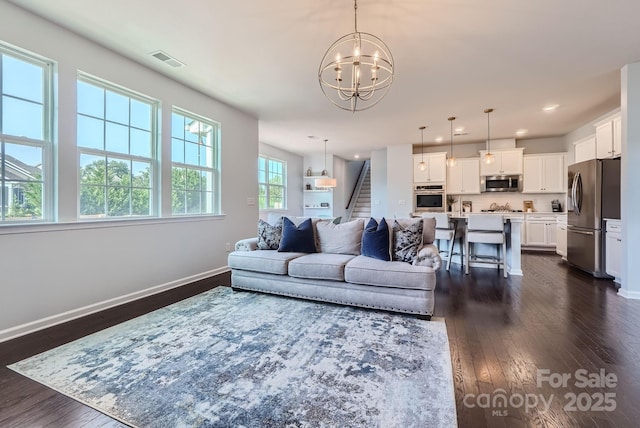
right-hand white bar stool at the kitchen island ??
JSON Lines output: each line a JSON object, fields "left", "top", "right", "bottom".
{"left": 464, "top": 214, "right": 507, "bottom": 278}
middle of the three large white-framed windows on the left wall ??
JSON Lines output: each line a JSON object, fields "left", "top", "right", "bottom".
{"left": 77, "top": 72, "right": 159, "bottom": 219}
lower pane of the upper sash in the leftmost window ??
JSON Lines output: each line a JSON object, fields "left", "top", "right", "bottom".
{"left": 2, "top": 96, "right": 44, "bottom": 140}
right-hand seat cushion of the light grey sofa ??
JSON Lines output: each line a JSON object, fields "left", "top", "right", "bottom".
{"left": 344, "top": 256, "right": 435, "bottom": 290}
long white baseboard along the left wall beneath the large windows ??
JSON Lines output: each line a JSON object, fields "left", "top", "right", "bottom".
{"left": 0, "top": 266, "right": 230, "bottom": 343}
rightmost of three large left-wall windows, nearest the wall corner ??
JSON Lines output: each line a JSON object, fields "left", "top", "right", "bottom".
{"left": 171, "top": 107, "right": 220, "bottom": 215}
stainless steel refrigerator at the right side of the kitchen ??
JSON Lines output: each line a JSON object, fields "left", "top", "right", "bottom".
{"left": 567, "top": 159, "right": 620, "bottom": 278}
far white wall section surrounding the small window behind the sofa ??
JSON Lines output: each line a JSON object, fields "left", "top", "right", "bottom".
{"left": 255, "top": 143, "right": 306, "bottom": 221}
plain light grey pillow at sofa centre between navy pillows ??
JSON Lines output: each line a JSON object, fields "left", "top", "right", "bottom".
{"left": 316, "top": 219, "right": 364, "bottom": 256}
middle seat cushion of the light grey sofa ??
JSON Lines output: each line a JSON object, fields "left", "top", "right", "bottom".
{"left": 289, "top": 253, "right": 355, "bottom": 281}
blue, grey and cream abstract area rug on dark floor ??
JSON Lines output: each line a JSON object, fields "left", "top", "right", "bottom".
{"left": 9, "top": 287, "right": 456, "bottom": 428}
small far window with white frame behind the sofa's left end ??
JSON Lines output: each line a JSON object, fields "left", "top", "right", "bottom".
{"left": 258, "top": 156, "right": 287, "bottom": 210}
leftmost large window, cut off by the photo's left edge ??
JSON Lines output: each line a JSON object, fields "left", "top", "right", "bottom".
{"left": 0, "top": 43, "right": 54, "bottom": 224}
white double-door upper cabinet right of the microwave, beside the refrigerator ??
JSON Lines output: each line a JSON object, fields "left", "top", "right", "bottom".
{"left": 522, "top": 153, "right": 567, "bottom": 193}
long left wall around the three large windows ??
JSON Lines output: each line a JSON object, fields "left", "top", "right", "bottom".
{"left": 0, "top": 2, "right": 258, "bottom": 341}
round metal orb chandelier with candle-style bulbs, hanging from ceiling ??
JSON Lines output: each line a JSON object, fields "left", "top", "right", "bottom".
{"left": 318, "top": 0, "right": 393, "bottom": 112}
